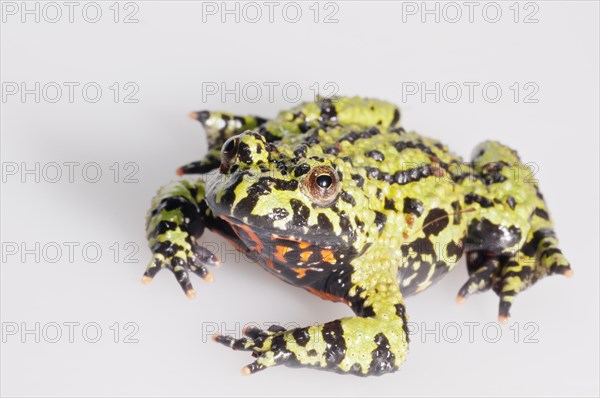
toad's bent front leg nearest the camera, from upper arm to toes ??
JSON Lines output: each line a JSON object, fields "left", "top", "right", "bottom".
{"left": 214, "top": 262, "right": 408, "bottom": 376}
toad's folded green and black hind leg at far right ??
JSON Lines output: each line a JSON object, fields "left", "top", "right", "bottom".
{"left": 457, "top": 142, "right": 572, "bottom": 322}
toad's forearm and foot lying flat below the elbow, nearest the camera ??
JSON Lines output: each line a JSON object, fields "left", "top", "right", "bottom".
{"left": 213, "top": 317, "right": 408, "bottom": 376}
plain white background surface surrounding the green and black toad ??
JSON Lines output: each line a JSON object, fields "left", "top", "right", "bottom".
{"left": 0, "top": 1, "right": 600, "bottom": 396}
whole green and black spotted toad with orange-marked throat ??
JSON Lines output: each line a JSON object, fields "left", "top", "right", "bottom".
{"left": 143, "top": 97, "right": 571, "bottom": 376}
